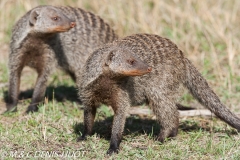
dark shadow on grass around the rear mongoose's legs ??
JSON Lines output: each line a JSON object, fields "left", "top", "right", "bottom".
{"left": 3, "top": 85, "right": 80, "bottom": 103}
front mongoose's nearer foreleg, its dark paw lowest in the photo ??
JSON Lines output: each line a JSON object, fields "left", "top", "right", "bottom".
{"left": 107, "top": 92, "right": 130, "bottom": 155}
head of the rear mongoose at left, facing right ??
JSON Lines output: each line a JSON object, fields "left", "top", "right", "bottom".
{"left": 29, "top": 6, "right": 76, "bottom": 33}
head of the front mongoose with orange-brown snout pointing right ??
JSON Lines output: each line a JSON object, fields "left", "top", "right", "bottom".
{"left": 105, "top": 48, "right": 152, "bottom": 76}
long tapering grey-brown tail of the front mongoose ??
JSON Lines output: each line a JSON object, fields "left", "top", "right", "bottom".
{"left": 183, "top": 58, "right": 240, "bottom": 131}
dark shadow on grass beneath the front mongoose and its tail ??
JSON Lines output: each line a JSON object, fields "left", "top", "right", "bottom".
{"left": 73, "top": 116, "right": 237, "bottom": 140}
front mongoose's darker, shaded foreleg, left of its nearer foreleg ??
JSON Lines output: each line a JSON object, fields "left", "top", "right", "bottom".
{"left": 77, "top": 105, "right": 97, "bottom": 141}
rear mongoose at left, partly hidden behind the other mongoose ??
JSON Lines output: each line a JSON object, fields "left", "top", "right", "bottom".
{"left": 7, "top": 6, "right": 117, "bottom": 112}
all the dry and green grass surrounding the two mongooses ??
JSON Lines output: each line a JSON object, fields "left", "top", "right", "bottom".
{"left": 0, "top": 0, "right": 240, "bottom": 159}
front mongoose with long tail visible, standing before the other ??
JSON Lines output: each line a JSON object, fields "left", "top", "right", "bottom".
{"left": 77, "top": 34, "right": 240, "bottom": 154}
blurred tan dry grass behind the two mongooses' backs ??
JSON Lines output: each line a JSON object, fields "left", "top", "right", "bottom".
{"left": 0, "top": 0, "right": 240, "bottom": 110}
